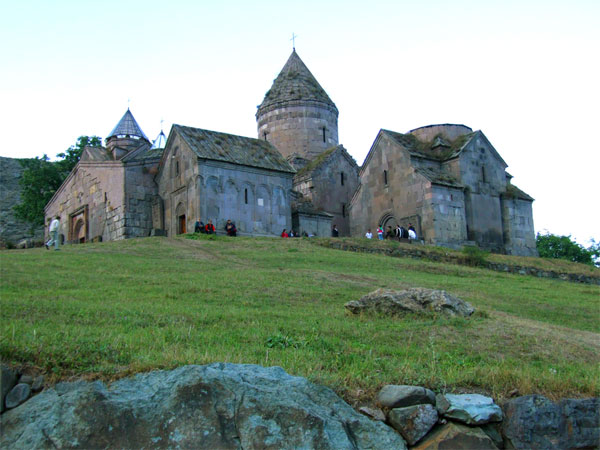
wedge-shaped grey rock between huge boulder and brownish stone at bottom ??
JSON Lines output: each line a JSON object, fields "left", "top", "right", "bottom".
{"left": 388, "top": 404, "right": 438, "bottom": 445}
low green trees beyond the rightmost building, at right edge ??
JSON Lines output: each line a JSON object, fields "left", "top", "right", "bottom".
{"left": 535, "top": 233, "right": 600, "bottom": 265}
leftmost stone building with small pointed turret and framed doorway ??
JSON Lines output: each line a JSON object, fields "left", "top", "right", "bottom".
{"left": 45, "top": 109, "right": 162, "bottom": 243}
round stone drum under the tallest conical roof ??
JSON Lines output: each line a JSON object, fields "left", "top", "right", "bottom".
{"left": 256, "top": 101, "right": 338, "bottom": 159}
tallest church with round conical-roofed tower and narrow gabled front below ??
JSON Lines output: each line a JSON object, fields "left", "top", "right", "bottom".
{"left": 256, "top": 50, "right": 358, "bottom": 236}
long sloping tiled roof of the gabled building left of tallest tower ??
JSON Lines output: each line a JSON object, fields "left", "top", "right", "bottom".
{"left": 171, "top": 125, "right": 295, "bottom": 173}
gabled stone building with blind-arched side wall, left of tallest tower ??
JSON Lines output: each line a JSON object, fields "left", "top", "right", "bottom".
{"left": 154, "top": 125, "right": 295, "bottom": 236}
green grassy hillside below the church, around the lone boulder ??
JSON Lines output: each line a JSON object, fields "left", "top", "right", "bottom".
{"left": 0, "top": 236, "right": 600, "bottom": 402}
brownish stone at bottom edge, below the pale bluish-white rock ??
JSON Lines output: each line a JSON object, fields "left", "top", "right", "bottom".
{"left": 411, "top": 422, "right": 498, "bottom": 450}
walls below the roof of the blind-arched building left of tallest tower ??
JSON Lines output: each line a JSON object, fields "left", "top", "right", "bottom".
{"left": 158, "top": 136, "right": 293, "bottom": 236}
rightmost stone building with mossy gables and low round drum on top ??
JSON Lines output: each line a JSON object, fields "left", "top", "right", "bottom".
{"left": 350, "top": 124, "right": 537, "bottom": 256}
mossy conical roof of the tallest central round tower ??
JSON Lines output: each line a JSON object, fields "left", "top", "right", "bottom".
{"left": 258, "top": 50, "right": 337, "bottom": 113}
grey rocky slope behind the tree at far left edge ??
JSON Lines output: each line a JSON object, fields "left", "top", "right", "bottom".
{"left": 0, "top": 156, "right": 44, "bottom": 247}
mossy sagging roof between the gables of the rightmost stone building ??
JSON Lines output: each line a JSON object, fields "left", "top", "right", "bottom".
{"left": 381, "top": 130, "right": 476, "bottom": 161}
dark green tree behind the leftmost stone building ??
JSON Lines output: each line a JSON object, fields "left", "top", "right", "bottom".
{"left": 14, "top": 136, "right": 102, "bottom": 225}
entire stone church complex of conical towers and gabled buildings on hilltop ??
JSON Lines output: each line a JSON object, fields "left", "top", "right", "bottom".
{"left": 45, "top": 50, "right": 535, "bottom": 254}
